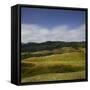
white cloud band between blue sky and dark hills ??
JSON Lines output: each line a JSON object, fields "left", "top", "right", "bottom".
{"left": 21, "top": 24, "right": 85, "bottom": 43}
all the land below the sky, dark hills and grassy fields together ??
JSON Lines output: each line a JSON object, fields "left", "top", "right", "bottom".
{"left": 21, "top": 41, "right": 86, "bottom": 83}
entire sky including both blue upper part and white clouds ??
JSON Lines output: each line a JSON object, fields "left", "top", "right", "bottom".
{"left": 21, "top": 7, "right": 85, "bottom": 43}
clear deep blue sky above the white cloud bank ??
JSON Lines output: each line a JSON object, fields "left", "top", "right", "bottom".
{"left": 21, "top": 8, "right": 85, "bottom": 28}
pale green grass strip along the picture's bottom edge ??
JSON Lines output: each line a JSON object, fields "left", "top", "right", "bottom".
{"left": 22, "top": 71, "right": 85, "bottom": 83}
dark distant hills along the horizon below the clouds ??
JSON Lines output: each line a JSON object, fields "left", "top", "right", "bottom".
{"left": 21, "top": 41, "right": 85, "bottom": 52}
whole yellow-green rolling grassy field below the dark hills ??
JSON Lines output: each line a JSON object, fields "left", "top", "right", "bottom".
{"left": 21, "top": 47, "right": 85, "bottom": 83}
